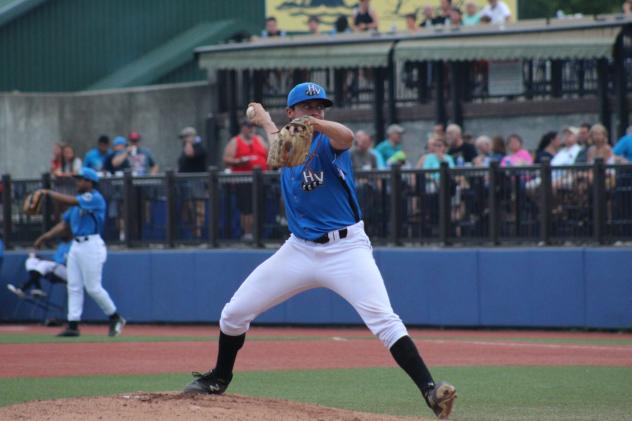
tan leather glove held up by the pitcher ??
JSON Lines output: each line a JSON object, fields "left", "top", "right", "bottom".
{"left": 268, "top": 117, "right": 314, "bottom": 168}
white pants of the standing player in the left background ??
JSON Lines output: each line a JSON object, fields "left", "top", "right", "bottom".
{"left": 68, "top": 234, "right": 116, "bottom": 322}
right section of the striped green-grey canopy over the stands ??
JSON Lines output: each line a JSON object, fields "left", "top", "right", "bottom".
{"left": 395, "top": 27, "right": 621, "bottom": 62}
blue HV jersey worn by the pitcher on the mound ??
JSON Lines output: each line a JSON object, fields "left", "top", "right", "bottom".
{"left": 281, "top": 133, "right": 362, "bottom": 240}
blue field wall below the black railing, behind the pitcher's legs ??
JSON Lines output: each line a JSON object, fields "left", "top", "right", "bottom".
{"left": 0, "top": 248, "right": 632, "bottom": 329}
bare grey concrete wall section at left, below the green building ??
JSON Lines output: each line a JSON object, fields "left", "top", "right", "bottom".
{"left": 0, "top": 83, "right": 210, "bottom": 178}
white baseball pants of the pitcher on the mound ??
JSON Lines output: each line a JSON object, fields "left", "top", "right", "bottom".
{"left": 220, "top": 221, "right": 408, "bottom": 348}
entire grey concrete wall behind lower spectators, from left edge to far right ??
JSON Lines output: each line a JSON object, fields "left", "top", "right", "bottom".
{"left": 0, "top": 82, "right": 624, "bottom": 178}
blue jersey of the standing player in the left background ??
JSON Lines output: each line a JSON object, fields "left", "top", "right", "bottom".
{"left": 64, "top": 190, "right": 105, "bottom": 237}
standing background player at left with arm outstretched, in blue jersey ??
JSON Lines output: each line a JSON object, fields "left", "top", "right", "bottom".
{"left": 35, "top": 168, "right": 125, "bottom": 336}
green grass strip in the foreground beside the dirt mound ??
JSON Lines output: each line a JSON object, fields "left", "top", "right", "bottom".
{"left": 0, "top": 367, "right": 632, "bottom": 421}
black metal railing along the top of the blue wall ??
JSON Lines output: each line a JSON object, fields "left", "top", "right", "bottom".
{"left": 0, "top": 161, "right": 632, "bottom": 247}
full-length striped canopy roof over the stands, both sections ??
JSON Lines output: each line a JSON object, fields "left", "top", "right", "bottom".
{"left": 195, "top": 15, "right": 632, "bottom": 71}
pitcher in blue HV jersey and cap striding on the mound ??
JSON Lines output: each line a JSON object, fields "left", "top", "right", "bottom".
{"left": 185, "top": 83, "right": 456, "bottom": 418}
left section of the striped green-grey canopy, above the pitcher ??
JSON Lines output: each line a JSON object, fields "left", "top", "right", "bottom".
{"left": 198, "top": 41, "right": 393, "bottom": 71}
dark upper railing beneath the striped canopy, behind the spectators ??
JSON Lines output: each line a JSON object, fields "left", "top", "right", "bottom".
{"left": 227, "top": 58, "right": 632, "bottom": 111}
